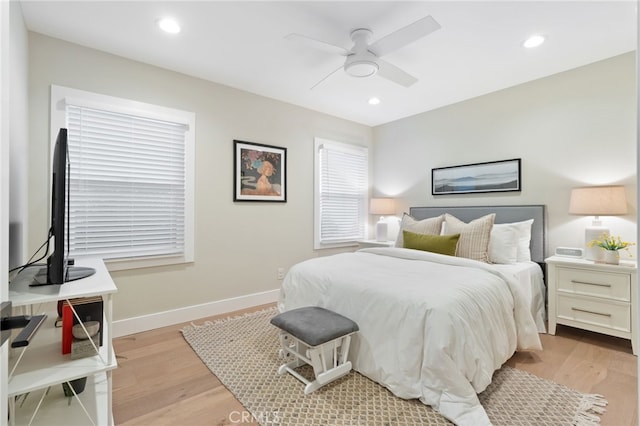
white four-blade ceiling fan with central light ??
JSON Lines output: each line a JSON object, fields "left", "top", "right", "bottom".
{"left": 285, "top": 15, "right": 440, "bottom": 89}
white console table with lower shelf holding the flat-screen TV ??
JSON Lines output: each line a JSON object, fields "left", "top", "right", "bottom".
{"left": 8, "top": 259, "right": 117, "bottom": 426}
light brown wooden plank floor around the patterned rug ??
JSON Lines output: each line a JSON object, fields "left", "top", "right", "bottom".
{"left": 113, "top": 306, "right": 638, "bottom": 426}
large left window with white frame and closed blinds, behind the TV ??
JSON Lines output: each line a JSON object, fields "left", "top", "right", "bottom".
{"left": 51, "top": 86, "right": 195, "bottom": 270}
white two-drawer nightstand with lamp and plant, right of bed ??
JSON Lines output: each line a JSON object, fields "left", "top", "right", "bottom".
{"left": 545, "top": 256, "right": 638, "bottom": 355}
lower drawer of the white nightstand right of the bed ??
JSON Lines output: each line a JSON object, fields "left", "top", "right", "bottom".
{"left": 557, "top": 294, "right": 631, "bottom": 332}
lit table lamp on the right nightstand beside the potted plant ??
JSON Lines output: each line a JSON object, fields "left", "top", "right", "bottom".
{"left": 569, "top": 185, "right": 627, "bottom": 260}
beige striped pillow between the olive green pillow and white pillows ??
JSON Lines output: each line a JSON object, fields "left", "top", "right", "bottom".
{"left": 444, "top": 213, "right": 496, "bottom": 263}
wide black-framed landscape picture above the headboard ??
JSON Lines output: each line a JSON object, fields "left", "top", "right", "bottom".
{"left": 431, "top": 158, "right": 522, "bottom": 195}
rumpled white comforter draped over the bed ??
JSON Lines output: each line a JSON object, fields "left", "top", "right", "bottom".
{"left": 279, "top": 248, "right": 542, "bottom": 426}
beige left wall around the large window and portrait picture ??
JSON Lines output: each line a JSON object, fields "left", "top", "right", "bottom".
{"left": 28, "top": 33, "right": 372, "bottom": 319}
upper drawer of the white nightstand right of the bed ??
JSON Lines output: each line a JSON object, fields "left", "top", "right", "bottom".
{"left": 556, "top": 267, "right": 631, "bottom": 302}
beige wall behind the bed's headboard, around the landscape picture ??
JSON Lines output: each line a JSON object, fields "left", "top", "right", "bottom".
{"left": 374, "top": 53, "right": 637, "bottom": 260}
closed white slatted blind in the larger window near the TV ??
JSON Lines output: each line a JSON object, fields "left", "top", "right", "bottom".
{"left": 66, "top": 104, "right": 188, "bottom": 260}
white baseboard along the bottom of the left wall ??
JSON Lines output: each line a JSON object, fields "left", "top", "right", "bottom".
{"left": 113, "top": 290, "right": 280, "bottom": 338}
